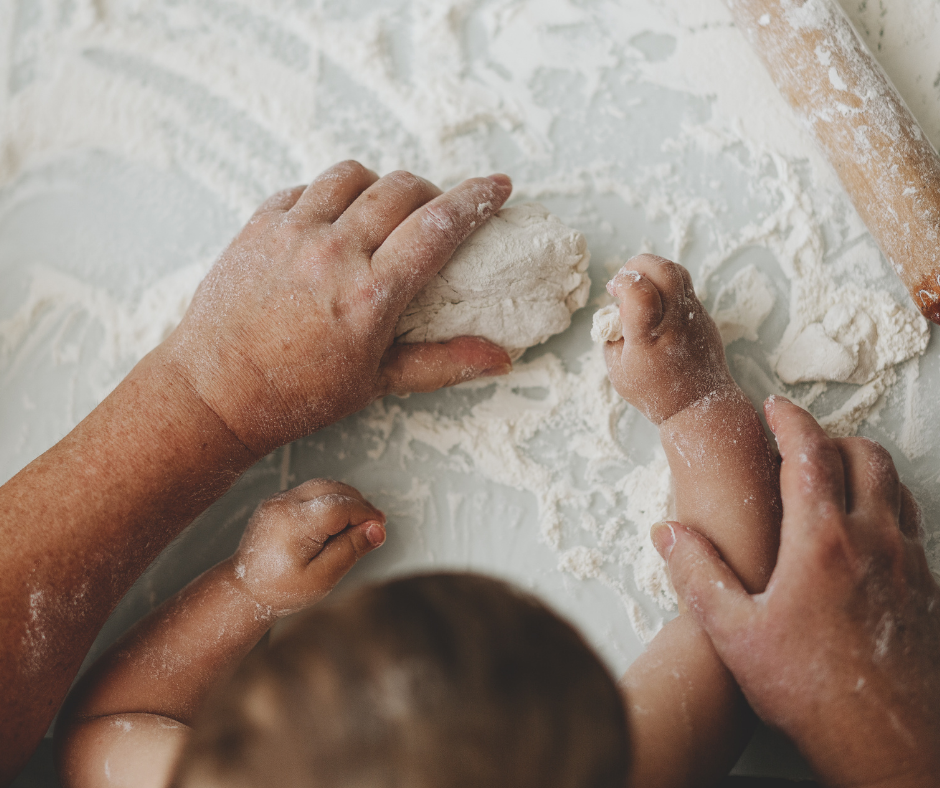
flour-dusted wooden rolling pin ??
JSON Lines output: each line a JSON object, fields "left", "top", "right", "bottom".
{"left": 725, "top": 0, "right": 940, "bottom": 323}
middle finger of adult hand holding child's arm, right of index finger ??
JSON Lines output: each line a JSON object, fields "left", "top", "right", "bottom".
{"left": 834, "top": 438, "right": 901, "bottom": 519}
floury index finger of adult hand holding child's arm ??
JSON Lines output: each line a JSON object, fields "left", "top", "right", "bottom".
{"left": 764, "top": 397, "right": 845, "bottom": 545}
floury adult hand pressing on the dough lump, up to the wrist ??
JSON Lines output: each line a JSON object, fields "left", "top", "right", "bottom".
{"left": 161, "top": 162, "right": 512, "bottom": 454}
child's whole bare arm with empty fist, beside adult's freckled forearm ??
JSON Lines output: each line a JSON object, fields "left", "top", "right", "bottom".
{"left": 56, "top": 479, "right": 385, "bottom": 788}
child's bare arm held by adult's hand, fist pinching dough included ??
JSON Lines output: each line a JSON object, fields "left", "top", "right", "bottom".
{"left": 605, "top": 255, "right": 782, "bottom": 786}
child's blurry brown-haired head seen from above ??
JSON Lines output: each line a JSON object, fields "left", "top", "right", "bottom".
{"left": 176, "top": 574, "right": 628, "bottom": 788}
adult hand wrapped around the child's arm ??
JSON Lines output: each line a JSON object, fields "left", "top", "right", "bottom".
{"left": 653, "top": 397, "right": 940, "bottom": 788}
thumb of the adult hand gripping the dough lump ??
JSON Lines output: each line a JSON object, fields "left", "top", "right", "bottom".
{"left": 381, "top": 337, "right": 512, "bottom": 394}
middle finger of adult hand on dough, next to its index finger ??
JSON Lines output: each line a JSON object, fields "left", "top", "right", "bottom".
{"left": 335, "top": 170, "right": 441, "bottom": 255}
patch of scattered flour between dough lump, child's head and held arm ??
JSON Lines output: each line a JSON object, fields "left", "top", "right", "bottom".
{"left": 360, "top": 346, "right": 676, "bottom": 641}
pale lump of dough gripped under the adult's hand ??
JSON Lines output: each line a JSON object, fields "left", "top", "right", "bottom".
{"left": 395, "top": 203, "right": 591, "bottom": 359}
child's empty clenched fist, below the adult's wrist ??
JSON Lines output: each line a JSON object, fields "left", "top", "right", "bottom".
{"left": 232, "top": 479, "right": 385, "bottom": 615}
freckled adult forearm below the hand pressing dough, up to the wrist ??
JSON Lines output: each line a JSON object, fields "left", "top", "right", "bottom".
{"left": 0, "top": 348, "right": 256, "bottom": 782}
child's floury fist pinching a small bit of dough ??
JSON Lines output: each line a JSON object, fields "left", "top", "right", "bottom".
{"left": 604, "top": 254, "right": 734, "bottom": 424}
